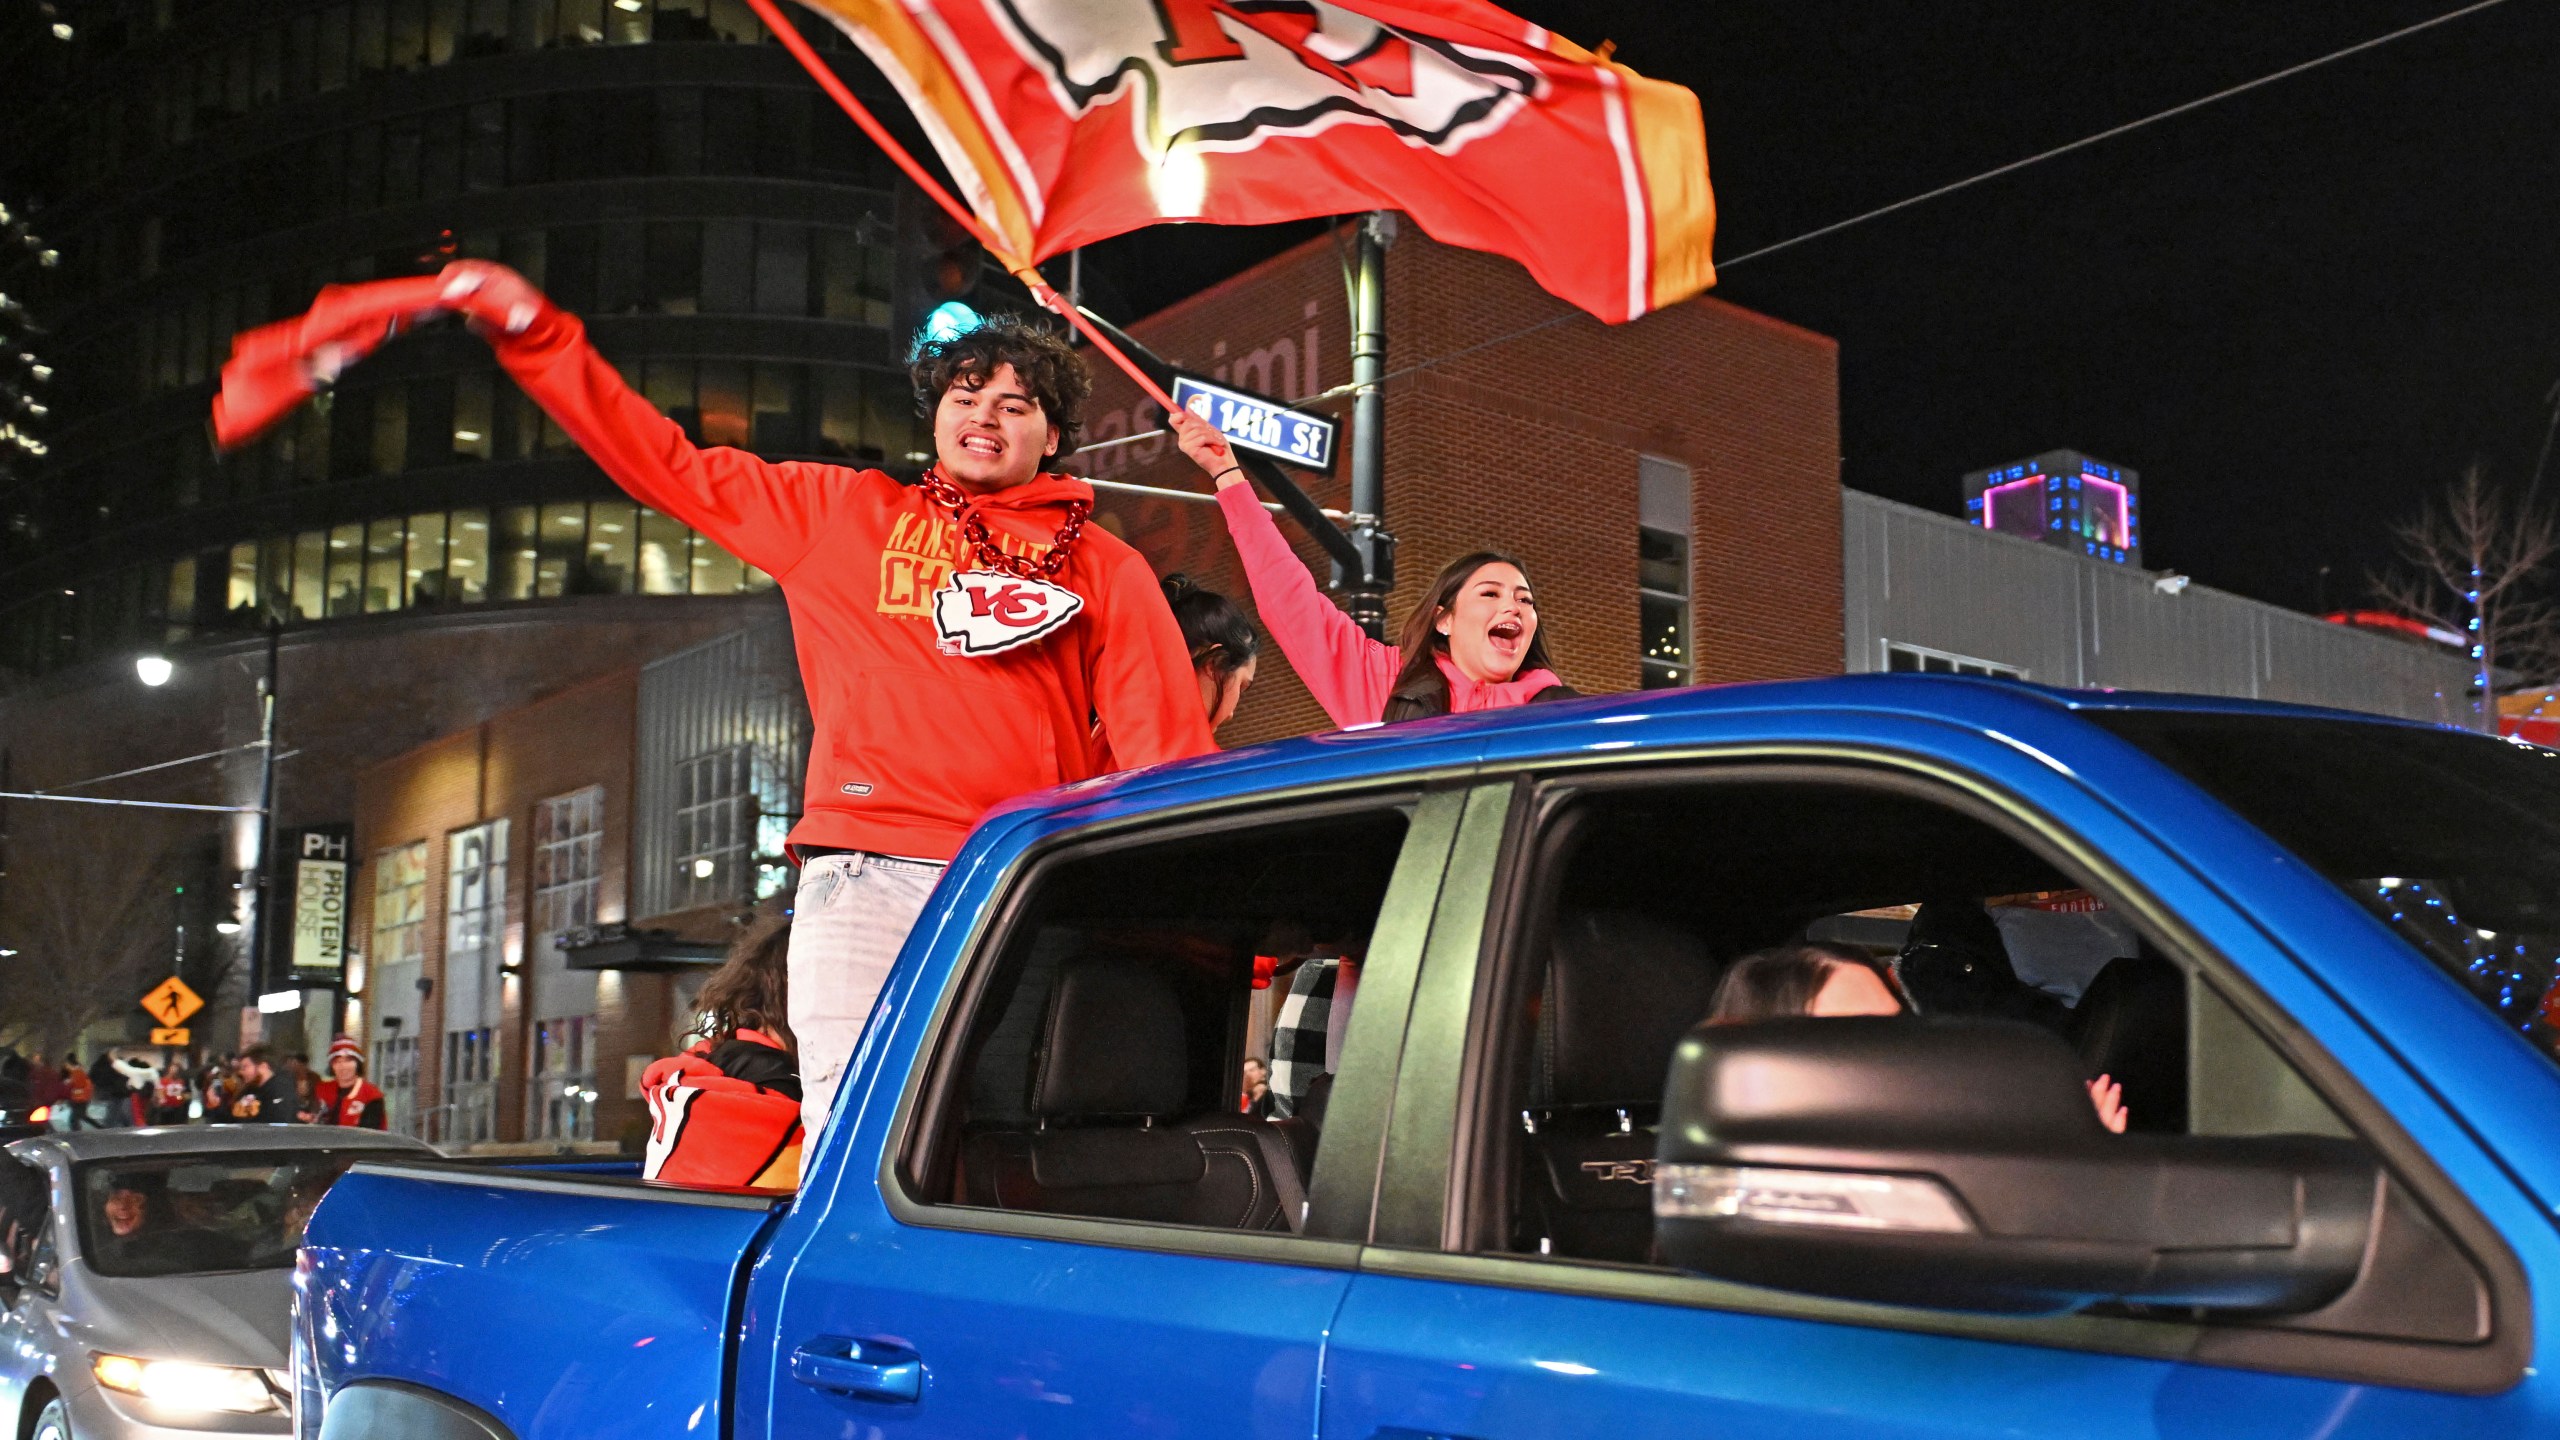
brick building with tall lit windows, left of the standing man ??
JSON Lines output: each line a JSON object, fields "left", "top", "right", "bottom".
{"left": 346, "top": 607, "right": 806, "bottom": 1145}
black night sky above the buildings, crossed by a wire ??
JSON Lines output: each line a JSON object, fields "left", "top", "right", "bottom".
{"left": 1085, "top": 0, "right": 2560, "bottom": 607}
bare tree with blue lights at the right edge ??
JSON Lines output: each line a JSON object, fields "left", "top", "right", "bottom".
{"left": 2373, "top": 464, "right": 2560, "bottom": 733}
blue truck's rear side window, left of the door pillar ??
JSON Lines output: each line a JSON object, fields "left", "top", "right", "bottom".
{"left": 911, "top": 807, "right": 1408, "bottom": 1232}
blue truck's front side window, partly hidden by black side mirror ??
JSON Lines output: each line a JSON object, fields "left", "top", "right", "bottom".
{"left": 1472, "top": 779, "right": 2348, "bottom": 1266}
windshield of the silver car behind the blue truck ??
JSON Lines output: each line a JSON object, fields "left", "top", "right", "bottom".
{"left": 74, "top": 1150, "right": 356, "bottom": 1279}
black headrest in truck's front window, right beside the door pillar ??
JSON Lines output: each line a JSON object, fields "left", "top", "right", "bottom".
{"left": 1536, "top": 910, "right": 1723, "bottom": 1104}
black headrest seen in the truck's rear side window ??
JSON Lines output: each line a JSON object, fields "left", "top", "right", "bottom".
{"left": 1032, "top": 961, "right": 1190, "bottom": 1120}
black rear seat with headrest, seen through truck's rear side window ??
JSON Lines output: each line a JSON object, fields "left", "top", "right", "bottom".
{"left": 965, "top": 961, "right": 1293, "bottom": 1230}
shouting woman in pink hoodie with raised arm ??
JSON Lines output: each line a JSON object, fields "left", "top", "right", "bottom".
{"left": 1172, "top": 413, "right": 1574, "bottom": 728}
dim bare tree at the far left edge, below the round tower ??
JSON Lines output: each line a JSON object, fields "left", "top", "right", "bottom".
{"left": 0, "top": 802, "right": 177, "bottom": 1056}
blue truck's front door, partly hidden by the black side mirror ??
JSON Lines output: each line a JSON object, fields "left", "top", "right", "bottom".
{"left": 1321, "top": 743, "right": 2550, "bottom": 1440}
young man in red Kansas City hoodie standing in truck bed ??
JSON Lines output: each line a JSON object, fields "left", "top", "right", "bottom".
{"left": 440, "top": 261, "right": 1216, "bottom": 1135}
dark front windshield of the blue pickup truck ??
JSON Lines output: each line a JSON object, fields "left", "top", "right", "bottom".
{"left": 2086, "top": 710, "right": 2560, "bottom": 1061}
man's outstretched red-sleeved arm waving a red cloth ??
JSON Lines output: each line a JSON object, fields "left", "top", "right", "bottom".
{"left": 440, "top": 261, "right": 850, "bottom": 579}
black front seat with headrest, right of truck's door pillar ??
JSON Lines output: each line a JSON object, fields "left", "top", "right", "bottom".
{"left": 1516, "top": 910, "right": 1720, "bottom": 1263}
